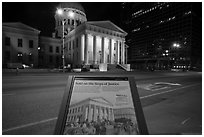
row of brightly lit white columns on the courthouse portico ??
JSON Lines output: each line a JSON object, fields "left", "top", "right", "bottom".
{"left": 79, "top": 34, "right": 126, "bottom": 64}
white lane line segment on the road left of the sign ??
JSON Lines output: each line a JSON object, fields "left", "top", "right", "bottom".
{"left": 2, "top": 117, "right": 57, "bottom": 133}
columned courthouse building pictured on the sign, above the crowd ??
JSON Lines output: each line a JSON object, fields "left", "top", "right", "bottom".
{"left": 67, "top": 97, "right": 114, "bottom": 122}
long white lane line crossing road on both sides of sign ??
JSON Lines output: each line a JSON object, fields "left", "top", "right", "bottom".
{"left": 2, "top": 83, "right": 200, "bottom": 133}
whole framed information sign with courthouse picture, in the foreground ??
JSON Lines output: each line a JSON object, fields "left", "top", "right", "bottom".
{"left": 55, "top": 76, "right": 148, "bottom": 135}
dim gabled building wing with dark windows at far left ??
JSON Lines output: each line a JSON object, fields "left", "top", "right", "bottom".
{"left": 2, "top": 22, "right": 40, "bottom": 67}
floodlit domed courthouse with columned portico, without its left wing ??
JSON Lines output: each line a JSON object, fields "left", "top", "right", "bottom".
{"left": 55, "top": 3, "right": 127, "bottom": 68}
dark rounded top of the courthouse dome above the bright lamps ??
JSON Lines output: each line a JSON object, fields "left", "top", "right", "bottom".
{"left": 59, "top": 2, "right": 85, "bottom": 13}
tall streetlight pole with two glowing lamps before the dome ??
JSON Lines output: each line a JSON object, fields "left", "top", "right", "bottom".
{"left": 56, "top": 8, "right": 74, "bottom": 72}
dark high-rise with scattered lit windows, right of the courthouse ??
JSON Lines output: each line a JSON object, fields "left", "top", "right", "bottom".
{"left": 121, "top": 2, "right": 202, "bottom": 69}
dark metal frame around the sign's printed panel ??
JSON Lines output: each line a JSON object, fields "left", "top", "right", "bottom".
{"left": 54, "top": 75, "right": 149, "bottom": 135}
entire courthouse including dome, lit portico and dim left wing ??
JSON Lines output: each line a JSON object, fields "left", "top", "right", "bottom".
{"left": 3, "top": 2, "right": 127, "bottom": 68}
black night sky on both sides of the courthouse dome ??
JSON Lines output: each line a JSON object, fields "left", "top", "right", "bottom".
{"left": 2, "top": 2, "right": 121, "bottom": 36}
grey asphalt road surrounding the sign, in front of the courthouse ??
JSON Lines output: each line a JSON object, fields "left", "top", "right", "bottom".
{"left": 2, "top": 72, "right": 202, "bottom": 135}
